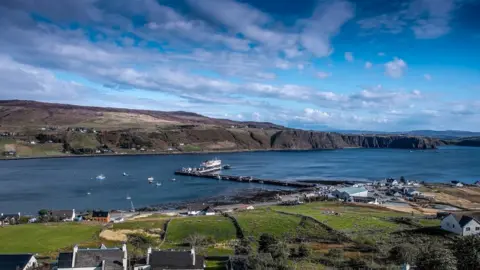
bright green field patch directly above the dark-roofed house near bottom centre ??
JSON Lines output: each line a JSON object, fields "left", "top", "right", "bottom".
{"left": 166, "top": 216, "right": 237, "bottom": 245}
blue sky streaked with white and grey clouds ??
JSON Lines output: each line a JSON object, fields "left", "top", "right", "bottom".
{"left": 0, "top": 0, "right": 480, "bottom": 131}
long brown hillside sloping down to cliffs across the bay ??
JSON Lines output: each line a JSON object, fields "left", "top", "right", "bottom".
{"left": 0, "top": 101, "right": 441, "bottom": 156}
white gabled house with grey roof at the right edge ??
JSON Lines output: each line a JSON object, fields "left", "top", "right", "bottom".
{"left": 440, "top": 212, "right": 480, "bottom": 236}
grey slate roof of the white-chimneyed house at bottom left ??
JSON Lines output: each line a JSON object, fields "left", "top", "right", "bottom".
{"left": 58, "top": 248, "right": 123, "bottom": 270}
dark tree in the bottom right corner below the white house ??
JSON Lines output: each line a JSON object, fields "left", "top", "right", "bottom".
{"left": 453, "top": 235, "right": 480, "bottom": 270}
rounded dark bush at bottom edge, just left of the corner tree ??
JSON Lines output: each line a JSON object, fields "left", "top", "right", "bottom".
{"left": 415, "top": 244, "right": 457, "bottom": 270}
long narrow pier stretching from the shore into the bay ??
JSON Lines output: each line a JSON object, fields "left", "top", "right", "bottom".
{"left": 175, "top": 170, "right": 315, "bottom": 188}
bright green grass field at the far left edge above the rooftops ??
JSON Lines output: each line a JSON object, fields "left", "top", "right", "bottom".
{"left": 0, "top": 223, "right": 101, "bottom": 255}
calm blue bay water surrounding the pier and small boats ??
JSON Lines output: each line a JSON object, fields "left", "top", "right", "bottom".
{"left": 0, "top": 147, "right": 480, "bottom": 213}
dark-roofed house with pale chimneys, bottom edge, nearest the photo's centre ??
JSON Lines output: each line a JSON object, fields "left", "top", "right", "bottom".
{"left": 134, "top": 248, "right": 205, "bottom": 270}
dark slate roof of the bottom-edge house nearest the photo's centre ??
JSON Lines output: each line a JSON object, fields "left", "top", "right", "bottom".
{"left": 150, "top": 250, "right": 204, "bottom": 270}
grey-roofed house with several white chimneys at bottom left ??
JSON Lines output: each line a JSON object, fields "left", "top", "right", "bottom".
{"left": 57, "top": 244, "right": 128, "bottom": 270}
